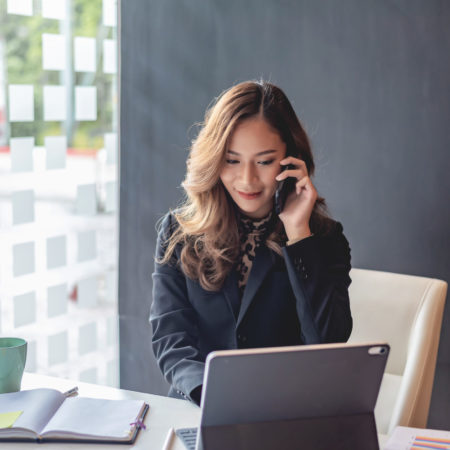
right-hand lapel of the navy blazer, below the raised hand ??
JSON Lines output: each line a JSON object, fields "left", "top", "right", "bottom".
{"left": 236, "top": 245, "right": 275, "bottom": 328}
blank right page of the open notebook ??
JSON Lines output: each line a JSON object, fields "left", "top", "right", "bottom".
{"left": 41, "top": 397, "right": 145, "bottom": 440}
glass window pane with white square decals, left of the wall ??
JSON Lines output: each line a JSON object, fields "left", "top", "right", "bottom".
{"left": 0, "top": 0, "right": 119, "bottom": 386}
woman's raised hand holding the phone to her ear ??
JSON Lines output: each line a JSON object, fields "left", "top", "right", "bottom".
{"left": 275, "top": 156, "right": 317, "bottom": 240}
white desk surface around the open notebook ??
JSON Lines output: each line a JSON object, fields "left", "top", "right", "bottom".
{"left": 1, "top": 373, "right": 200, "bottom": 450}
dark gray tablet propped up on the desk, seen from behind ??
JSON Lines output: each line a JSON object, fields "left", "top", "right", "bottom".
{"left": 197, "top": 343, "right": 389, "bottom": 450}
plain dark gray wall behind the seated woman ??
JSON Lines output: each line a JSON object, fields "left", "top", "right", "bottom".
{"left": 119, "top": 0, "right": 450, "bottom": 428}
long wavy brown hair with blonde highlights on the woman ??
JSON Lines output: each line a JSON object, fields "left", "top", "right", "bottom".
{"left": 158, "top": 81, "right": 331, "bottom": 291}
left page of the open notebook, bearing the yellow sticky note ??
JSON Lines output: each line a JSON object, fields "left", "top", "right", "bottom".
{"left": 0, "top": 389, "right": 65, "bottom": 436}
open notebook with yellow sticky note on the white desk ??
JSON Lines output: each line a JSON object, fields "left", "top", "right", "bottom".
{"left": 0, "top": 389, "right": 149, "bottom": 444}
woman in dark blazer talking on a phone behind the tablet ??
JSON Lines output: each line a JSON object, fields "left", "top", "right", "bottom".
{"left": 150, "top": 81, "right": 352, "bottom": 404}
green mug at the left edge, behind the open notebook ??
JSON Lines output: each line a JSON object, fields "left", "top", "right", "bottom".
{"left": 0, "top": 338, "right": 27, "bottom": 394}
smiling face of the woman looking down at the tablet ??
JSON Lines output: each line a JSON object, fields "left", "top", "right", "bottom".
{"left": 220, "top": 117, "right": 286, "bottom": 218}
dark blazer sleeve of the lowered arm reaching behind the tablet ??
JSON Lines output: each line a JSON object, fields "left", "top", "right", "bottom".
{"left": 150, "top": 213, "right": 205, "bottom": 401}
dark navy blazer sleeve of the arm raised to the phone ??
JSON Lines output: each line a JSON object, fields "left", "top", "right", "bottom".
{"left": 283, "top": 222, "right": 353, "bottom": 344}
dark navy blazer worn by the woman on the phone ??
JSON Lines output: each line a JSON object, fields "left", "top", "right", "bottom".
{"left": 150, "top": 213, "right": 352, "bottom": 400}
